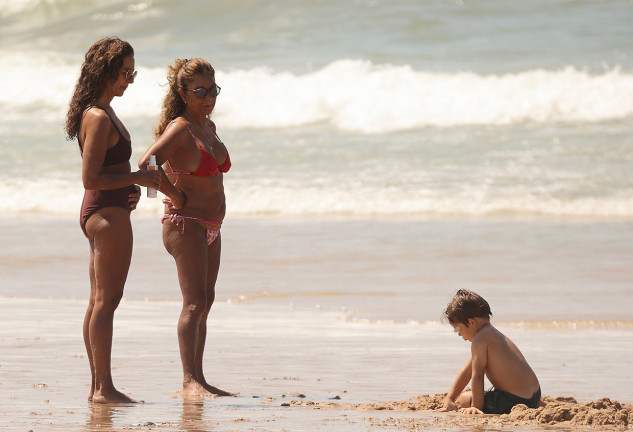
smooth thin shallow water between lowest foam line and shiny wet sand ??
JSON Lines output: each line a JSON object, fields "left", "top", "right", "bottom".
{"left": 0, "top": 215, "right": 633, "bottom": 327}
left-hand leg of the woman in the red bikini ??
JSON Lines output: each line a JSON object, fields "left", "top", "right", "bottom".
{"left": 163, "top": 220, "right": 211, "bottom": 396}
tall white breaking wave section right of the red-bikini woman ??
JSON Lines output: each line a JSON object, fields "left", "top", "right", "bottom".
{"left": 218, "top": 60, "right": 633, "bottom": 133}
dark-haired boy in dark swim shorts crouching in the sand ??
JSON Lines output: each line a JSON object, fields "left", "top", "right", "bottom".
{"left": 440, "top": 289, "right": 541, "bottom": 414}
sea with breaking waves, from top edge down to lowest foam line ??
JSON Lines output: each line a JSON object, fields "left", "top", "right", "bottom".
{"left": 0, "top": 0, "right": 633, "bottom": 220}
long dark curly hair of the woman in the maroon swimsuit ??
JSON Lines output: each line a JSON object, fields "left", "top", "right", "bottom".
{"left": 65, "top": 37, "right": 134, "bottom": 140}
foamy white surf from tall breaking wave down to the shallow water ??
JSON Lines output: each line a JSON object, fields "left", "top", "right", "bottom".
{"left": 0, "top": 51, "right": 633, "bottom": 218}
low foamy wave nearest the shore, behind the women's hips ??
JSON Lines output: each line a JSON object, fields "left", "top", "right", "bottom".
{"left": 3, "top": 178, "right": 633, "bottom": 219}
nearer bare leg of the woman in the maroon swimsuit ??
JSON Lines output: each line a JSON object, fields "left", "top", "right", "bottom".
{"left": 86, "top": 207, "right": 136, "bottom": 403}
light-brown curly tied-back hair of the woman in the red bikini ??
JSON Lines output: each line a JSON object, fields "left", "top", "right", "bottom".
{"left": 154, "top": 57, "right": 215, "bottom": 138}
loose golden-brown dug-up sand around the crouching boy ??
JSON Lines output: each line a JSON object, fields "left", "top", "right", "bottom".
{"left": 284, "top": 393, "right": 633, "bottom": 430}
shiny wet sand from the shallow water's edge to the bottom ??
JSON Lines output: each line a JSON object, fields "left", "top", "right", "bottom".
{"left": 0, "top": 297, "right": 633, "bottom": 432}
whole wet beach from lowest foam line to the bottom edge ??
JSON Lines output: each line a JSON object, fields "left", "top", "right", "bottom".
{"left": 0, "top": 216, "right": 633, "bottom": 432}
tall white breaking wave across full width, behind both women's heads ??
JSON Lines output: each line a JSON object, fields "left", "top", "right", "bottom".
{"left": 0, "top": 52, "right": 633, "bottom": 134}
